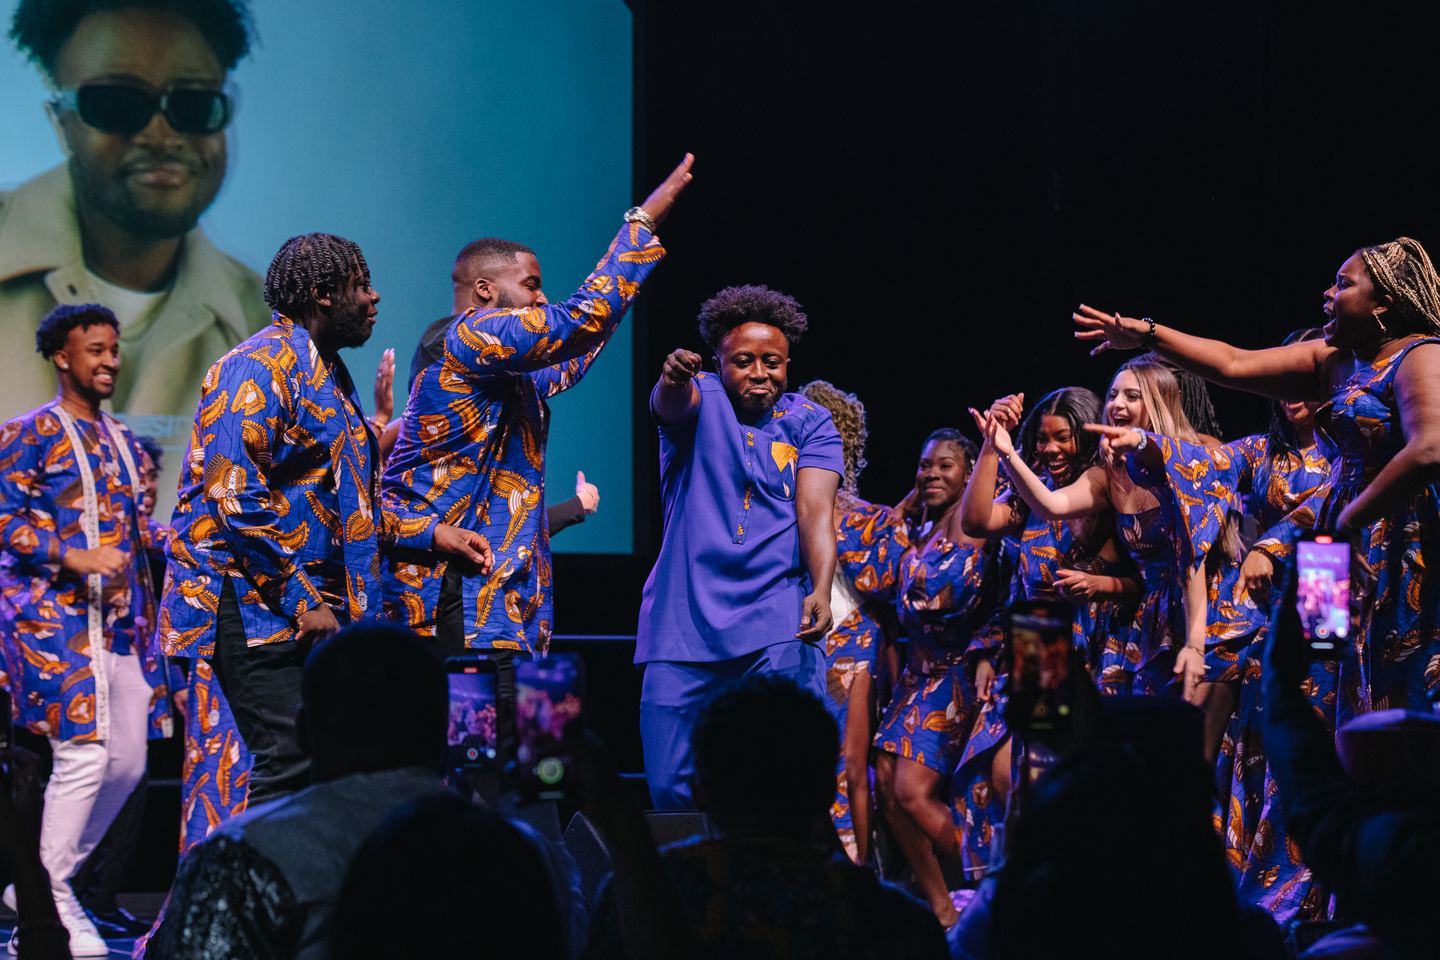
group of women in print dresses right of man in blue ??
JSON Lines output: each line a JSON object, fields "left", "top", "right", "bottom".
{"left": 802, "top": 237, "right": 1440, "bottom": 924}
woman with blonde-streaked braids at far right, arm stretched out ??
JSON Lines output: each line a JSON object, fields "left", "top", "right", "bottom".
{"left": 1074, "top": 237, "right": 1440, "bottom": 724}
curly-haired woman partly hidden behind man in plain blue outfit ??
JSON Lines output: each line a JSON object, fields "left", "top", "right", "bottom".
{"left": 799, "top": 380, "right": 907, "bottom": 864}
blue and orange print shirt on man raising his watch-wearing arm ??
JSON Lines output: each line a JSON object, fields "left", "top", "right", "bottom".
{"left": 384, "top": 223, "right": 665, "bottom": 652}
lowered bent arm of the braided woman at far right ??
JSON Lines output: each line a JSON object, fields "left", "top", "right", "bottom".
{"left": 1336, "top": 344, "right": 1440, "bottom": 537}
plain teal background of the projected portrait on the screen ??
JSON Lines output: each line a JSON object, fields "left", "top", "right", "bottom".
{"left": 0, "top": 0, "right": 634, "bottom": 553}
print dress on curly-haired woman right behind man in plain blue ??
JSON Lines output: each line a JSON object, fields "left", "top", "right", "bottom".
{"left": 825, "top": 499, "right": 909, "bottom": 859}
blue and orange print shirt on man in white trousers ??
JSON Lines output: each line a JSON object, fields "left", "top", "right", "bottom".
{"left": 0, "top": 402, "right": 170, "bottom": 740}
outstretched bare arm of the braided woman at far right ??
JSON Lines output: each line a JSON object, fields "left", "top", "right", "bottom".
{"left": 1073, "top": 304, "right": 1336, "bottom": 400}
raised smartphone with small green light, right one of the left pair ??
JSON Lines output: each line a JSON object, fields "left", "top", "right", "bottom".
{"left": 516, "top": 653, "right": 585, "bottom": 803}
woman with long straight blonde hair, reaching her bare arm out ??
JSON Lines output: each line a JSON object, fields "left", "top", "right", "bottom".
{"left": 973, "top": 358, "right": 1210, "bottom": 701}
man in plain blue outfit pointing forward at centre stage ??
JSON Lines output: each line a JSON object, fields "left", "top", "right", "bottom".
{"left": 635, "top": 286, "right": 844, "bottom": 810}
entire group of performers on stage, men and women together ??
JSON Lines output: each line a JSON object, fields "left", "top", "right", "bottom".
{"left": 0, "top": 131, "right": 1440, "bottom": 948}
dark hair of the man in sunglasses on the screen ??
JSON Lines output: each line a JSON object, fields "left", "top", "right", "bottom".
{"left": 10, "top": 0, "right": 255, "bottom": 81}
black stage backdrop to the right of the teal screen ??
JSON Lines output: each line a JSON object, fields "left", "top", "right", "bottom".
{"left": 556, "top": 0, "right": 1440, "bottom": 641}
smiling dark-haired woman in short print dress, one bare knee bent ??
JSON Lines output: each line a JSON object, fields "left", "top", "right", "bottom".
{"left": 876, "top": 429, "right": 1004, "bottom": 928}
